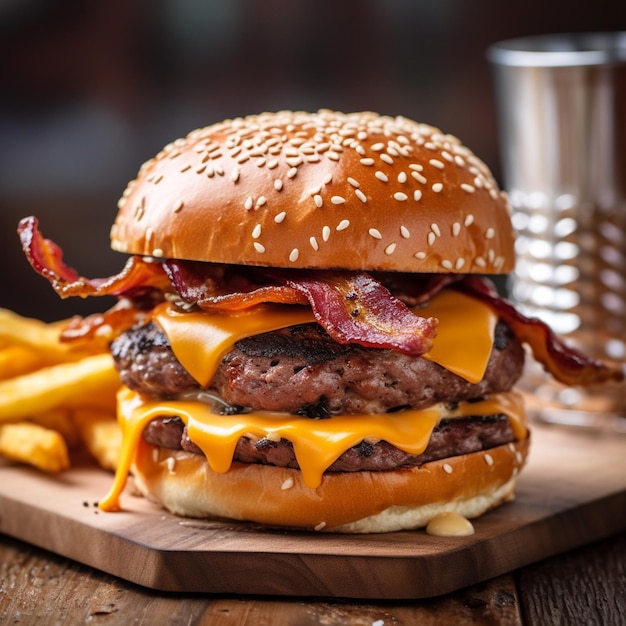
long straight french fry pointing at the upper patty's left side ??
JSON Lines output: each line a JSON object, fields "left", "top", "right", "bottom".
{"left": 0, "top": 354, "right": 120, "bottom": 423}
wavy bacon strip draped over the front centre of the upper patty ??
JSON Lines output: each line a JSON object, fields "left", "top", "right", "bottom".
{"left": 164, "top": 260, "right": 437, "bottom": 356}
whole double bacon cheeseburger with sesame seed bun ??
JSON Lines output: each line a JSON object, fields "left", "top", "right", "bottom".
{"left": 19, "top": 111, "right": 618, "bottom": 532}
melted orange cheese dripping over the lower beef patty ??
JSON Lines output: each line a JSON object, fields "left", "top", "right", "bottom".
{"left": 100, "top": 389, "right": 526, "bottom": 511}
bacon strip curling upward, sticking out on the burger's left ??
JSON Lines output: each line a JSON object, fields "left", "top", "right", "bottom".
{"left": 17, "top": 217, "right": 169, "bottom": 298}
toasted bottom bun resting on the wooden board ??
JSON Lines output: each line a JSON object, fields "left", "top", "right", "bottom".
{"left": 132, "top": 438, "right": 529, "bottom": 533}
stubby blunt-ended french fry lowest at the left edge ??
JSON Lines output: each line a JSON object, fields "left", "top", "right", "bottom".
{"left": 0, "top": 422, "right": 70, "bottom": 473}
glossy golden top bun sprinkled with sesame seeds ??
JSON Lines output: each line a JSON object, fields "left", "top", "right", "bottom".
{"left": 111, "top": 110, "right": 514, "bottom": 274}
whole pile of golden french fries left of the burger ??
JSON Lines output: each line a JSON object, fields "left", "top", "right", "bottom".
{"left": 0, "top": 308, "right": 121, "bottom": 473}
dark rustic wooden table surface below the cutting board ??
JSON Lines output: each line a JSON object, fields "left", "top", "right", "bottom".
{"left": 0, "top": 532, "right": 626, "bottom": 626}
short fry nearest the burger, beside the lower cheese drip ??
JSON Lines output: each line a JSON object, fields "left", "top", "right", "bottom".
{"left": 74, "top": 409, "right": 122, "bottom": 470}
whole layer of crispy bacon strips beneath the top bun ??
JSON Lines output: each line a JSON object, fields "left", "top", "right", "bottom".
{"left": 18, "top": 217, "right": 624, "bottom": 385}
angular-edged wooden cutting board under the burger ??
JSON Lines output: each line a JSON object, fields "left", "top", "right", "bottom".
{"left": 0, "top": 425, "right": 626, "bottom": 599}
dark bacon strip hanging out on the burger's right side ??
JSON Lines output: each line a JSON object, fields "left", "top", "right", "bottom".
{"left": 457, "top": 275, "right": 624, "bottom": 385}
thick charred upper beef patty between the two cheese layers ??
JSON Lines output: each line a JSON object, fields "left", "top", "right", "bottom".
{"left": 112, "top": 322, "right": 524, "bottom": 417}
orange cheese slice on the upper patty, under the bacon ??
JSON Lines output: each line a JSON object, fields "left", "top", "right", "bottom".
{"left": 153, "top": 290, "right": 498, "bottom": 387}
